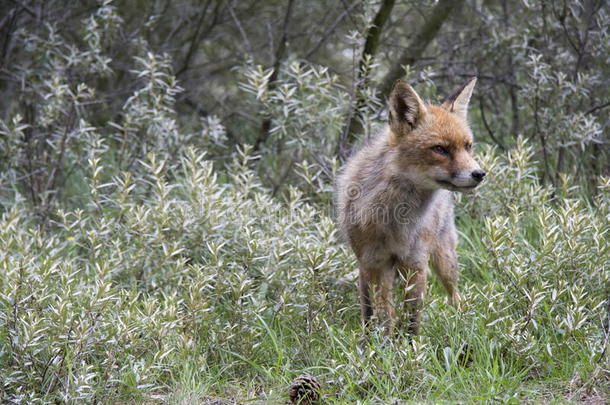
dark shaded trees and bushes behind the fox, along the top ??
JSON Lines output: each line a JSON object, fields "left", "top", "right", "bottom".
{"left": 0, "top": 0, "right": 609, "bottom": 206}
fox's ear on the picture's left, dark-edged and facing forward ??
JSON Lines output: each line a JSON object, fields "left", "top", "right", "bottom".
{"left": 389, "top": 80, "right": 427, "bottom": 135}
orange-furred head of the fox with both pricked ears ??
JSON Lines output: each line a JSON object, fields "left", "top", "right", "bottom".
{"left": 389, "top": 77, "right": 485, "bottom": 191}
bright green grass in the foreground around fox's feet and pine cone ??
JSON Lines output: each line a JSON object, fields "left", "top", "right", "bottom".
{"left": 159, "top": 219, "right": 610, "bottom": 404}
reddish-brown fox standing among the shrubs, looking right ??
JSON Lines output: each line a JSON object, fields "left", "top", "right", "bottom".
{"left": 336, "top": 77, "right": 486, "bottom": 335}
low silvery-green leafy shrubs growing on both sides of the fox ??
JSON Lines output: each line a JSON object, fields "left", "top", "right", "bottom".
{"left": 0, "top": 142, "right": 610, "bottom": 403}
